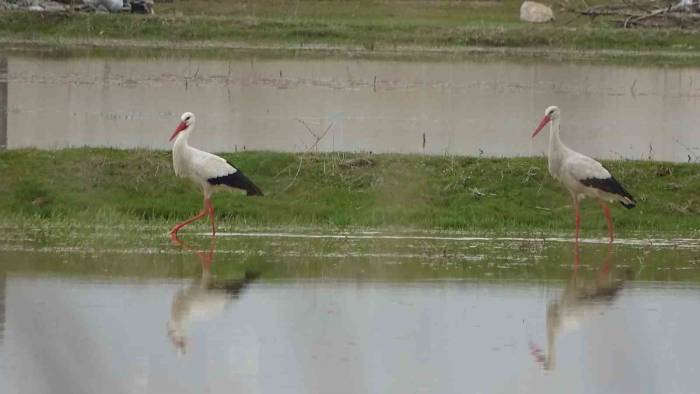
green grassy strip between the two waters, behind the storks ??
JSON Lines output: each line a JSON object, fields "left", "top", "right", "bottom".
{"left": 0, "top": 149, "right": 700, "bottom": 237}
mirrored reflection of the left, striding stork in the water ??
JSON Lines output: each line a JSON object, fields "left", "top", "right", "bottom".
{"left": 168, "top": 237, "right": 259, "bottom": 354}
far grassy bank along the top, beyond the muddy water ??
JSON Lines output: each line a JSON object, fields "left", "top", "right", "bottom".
{"left": 0, "top": 0, "right": 700, "bottom": 60}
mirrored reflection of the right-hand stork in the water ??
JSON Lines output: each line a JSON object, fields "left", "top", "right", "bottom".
{"left": 530, "top": 243, "right": 624, "bottom": 370}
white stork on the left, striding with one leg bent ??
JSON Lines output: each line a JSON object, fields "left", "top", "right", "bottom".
{"left": 170, "top": 112, "right": 263, "bottom": 242}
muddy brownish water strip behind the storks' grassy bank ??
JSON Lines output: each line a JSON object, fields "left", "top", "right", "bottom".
{"left": 0, "top": 55, "right": 700, "bottom": 162}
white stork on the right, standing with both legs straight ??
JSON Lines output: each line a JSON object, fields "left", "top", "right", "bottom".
{"left": 532, "top": 105, "right": 636, "bottom": 242}
